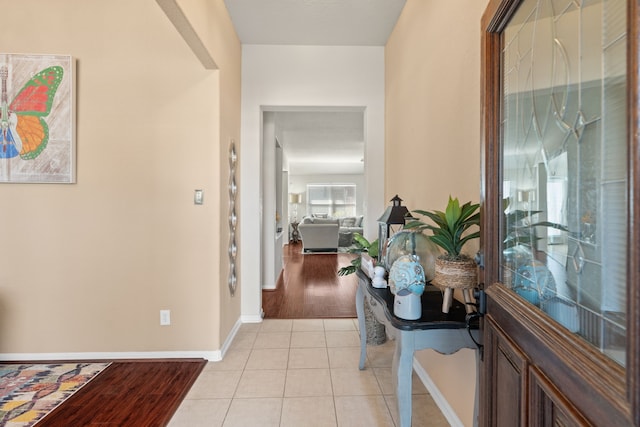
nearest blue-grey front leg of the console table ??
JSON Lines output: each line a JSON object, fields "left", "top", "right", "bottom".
{"left": 392, "top": 331, "right": 415, "bottom": 427}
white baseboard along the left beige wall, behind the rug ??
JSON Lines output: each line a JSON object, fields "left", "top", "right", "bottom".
{"left": 0, "top": 350, "right": 222, "bottom": 361}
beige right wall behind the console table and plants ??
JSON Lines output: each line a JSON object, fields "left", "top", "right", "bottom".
{"left": 385, "top": 0, "right": 488, "bottom": 426}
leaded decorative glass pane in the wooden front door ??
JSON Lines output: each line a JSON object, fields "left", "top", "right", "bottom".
{"left": 501, "top": 0, "right": 628, "bottom": 364}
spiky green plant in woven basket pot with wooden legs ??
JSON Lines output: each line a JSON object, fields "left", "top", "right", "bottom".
{"left": 405, "top": 196, "right": 480, "bottom": 312}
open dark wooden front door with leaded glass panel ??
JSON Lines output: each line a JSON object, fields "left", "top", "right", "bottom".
{"left": 479, "top": 0, "right": 640, "bottom": 427}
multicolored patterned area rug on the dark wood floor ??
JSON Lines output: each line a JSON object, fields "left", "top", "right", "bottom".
{"left": 0, "top": 363, "right": 109, "bottom": 427}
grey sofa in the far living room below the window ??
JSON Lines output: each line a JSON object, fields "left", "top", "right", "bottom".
{"left": 298, "top": 217, "right": 363, "bottom": 252}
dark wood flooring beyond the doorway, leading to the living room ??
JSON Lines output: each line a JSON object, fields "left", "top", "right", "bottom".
{"left": 262, "top": 243, "right": 358, "bottom": 319}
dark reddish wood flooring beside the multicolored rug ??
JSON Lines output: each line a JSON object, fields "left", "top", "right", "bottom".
{"left": 38, "top": 359, "right": 206, "bottom": 427}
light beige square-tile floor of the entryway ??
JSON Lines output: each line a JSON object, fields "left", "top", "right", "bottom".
{"left": 169, "top": 319, "right": 449, "bottom": 427}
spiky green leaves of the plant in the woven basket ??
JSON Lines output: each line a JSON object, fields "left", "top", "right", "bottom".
{"left": 405, "top": 196, "right": 480, "bottom": 260}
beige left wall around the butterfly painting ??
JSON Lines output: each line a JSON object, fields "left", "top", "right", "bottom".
{"left": 0, "top": 0, "right": 240, "bottom": 354}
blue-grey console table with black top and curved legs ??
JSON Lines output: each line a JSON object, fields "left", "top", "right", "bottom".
{"left": 356, "top": 270, "right": 480, "bottom": 427}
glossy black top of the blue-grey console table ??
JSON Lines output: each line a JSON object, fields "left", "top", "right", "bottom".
{"left": 357, "top": 270, "right": 477, "bottom": 330}
